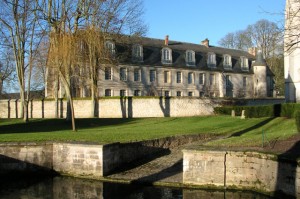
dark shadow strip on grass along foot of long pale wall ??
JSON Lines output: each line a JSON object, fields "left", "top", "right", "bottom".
{"left": 0, "top": 118, "right": 139, "bottom": 135}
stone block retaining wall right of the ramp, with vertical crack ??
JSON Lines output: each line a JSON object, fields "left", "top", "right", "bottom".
{"left": 183, "top": 150, "right": 300, "bottom": 197}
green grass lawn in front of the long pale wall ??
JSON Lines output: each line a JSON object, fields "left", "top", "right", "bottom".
{"left": 0, "top": 116, "right": 296, "bottom": 146}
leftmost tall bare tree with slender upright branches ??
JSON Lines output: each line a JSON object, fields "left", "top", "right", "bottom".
{"left": 0, "top": 0, "right": 41, "bottom": 122}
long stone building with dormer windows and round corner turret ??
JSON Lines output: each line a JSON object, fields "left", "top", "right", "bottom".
{"left": 46, "top": 36, "right": 274, "bottom": 98}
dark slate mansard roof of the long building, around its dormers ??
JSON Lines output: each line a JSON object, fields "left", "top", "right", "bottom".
{"left": 115, "top": 37, "right": 255, "bottom": 73}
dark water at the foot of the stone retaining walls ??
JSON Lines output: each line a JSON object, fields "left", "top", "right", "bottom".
{"left": 0, "top": 177, "right": 270, "bottom": 199}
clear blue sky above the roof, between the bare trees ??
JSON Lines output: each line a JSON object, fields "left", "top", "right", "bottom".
{"left": 144, "top": 0, "right": 285, "bottom": 45}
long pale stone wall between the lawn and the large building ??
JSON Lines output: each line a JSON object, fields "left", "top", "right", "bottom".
{"left": 0, "top": 97, "right": 216, "bottom": 118}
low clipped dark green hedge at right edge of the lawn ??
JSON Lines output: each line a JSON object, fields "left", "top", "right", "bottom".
{"left": 214, "top": 103, "right": 300, "bottom": 118}
